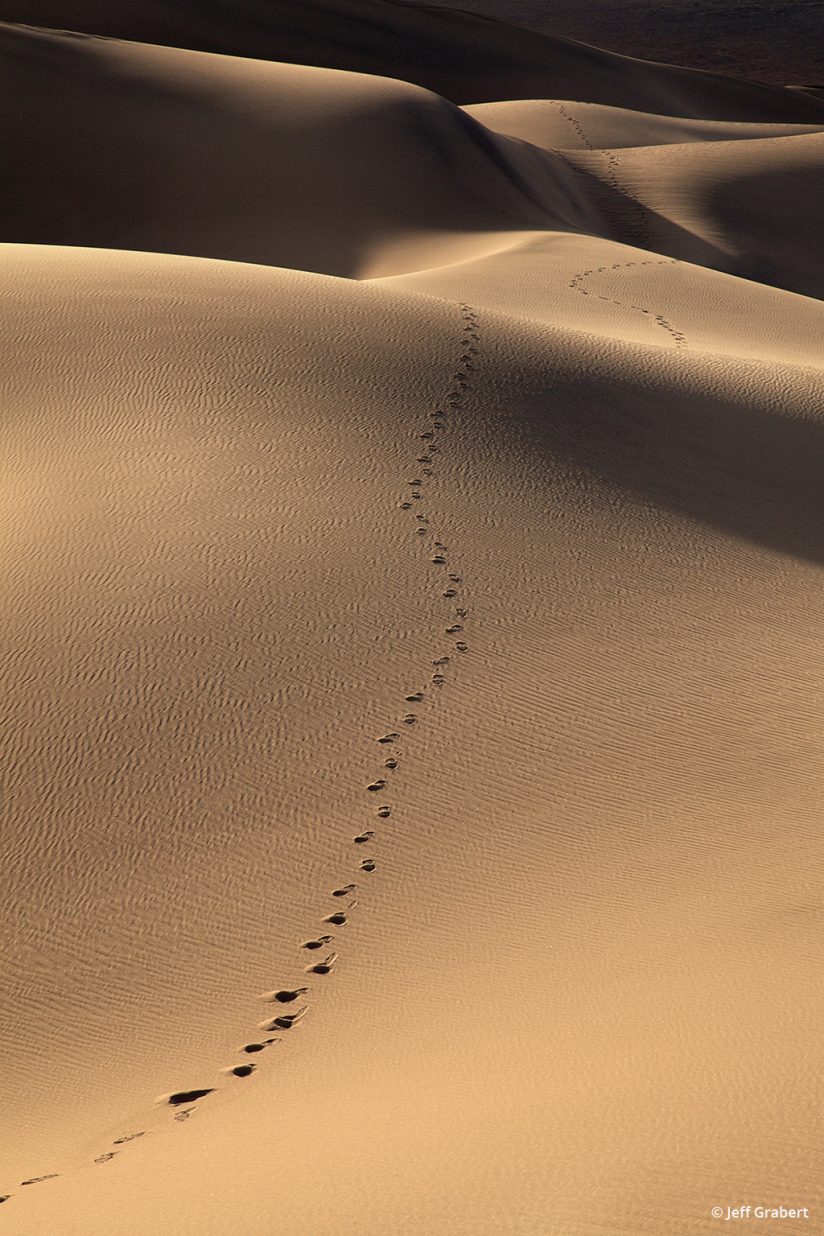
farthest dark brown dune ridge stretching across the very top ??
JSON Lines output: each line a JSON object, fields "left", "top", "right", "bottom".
{"left": 0, "top": 0, "right": 824, "bottom": 122}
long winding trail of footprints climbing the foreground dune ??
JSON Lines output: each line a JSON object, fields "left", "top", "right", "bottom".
{"left": 0, "top": 303, "right": 479, "bottom": 1203}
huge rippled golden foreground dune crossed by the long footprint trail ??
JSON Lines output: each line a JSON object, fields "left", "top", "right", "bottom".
{"left": 2, "top": 246, "right": 824, "bottom": 1236}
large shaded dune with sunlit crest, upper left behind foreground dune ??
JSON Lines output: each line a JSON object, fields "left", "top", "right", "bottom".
{"left": 0, "top": 27, "right": 574, "bottom": 276}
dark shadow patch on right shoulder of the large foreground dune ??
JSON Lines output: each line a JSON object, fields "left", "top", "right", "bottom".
{"left": 513, "top": 353, "right": 824, "bottom": 565}
